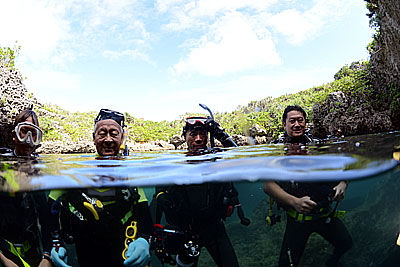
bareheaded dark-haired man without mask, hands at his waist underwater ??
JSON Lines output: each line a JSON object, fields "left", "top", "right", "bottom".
{"left": 264, "top": 106, "right": 352, "bottom": 267}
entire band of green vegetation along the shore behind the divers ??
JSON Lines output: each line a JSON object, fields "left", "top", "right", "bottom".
{"left": 33, "top": 59, "right": 376, "bottom": 142}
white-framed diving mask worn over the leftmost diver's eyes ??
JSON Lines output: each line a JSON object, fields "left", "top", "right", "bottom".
{"left": 14, "top": 121, "right": 43, "bottom": 147}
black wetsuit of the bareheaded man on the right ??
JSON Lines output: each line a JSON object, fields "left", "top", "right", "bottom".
{"left": 277, "top": 134, "right": 352, "bottom": 267}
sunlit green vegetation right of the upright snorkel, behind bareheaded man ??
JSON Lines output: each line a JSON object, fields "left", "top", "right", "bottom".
{"left": 215, "top": 62, "right": 373, "bottom": 138}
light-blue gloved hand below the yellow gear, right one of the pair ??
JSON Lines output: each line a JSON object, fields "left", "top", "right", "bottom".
{"left": 124, "top": 237, "right": 150, "bottom": 267}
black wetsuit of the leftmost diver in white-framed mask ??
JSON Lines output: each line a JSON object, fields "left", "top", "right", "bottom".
{"left": 0, "top": 148, "right": 57, "bottom": 266}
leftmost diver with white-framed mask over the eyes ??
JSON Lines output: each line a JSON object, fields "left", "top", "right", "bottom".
{"left": 0, "top": 110, "right": 57, "bottom": 267}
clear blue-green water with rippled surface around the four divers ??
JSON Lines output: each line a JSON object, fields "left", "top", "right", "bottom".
{"left": 0, "top": 132, "right": 400, "bottom": 266}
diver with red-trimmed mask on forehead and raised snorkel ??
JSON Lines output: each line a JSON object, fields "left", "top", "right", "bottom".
{"left": 151, "top": 104, "right": 250, "bottom": 267}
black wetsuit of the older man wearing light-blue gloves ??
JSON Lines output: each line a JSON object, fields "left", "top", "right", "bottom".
{"left": 50, "top": 188, "right": 153, "bottom": 267}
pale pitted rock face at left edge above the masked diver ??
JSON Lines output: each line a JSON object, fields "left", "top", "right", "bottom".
{"left": 0, "top": 64, "right": 40, "bottom": 147}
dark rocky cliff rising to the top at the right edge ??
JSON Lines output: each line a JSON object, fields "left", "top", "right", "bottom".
{"left": 313, "top": 0, "right": 400, "bottom": 137}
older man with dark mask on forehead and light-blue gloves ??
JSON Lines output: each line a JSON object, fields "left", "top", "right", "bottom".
{"left": 50, "top": 109, "right": 153, "bottom": 267}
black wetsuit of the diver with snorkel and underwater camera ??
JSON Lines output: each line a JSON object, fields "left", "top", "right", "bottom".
{"left": 152, "top": 183, "right": 239, "bottom": 267}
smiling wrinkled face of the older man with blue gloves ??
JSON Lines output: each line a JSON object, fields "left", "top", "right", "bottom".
{"left": 94, "top": 119, "right": 122, "bottom": 156}
